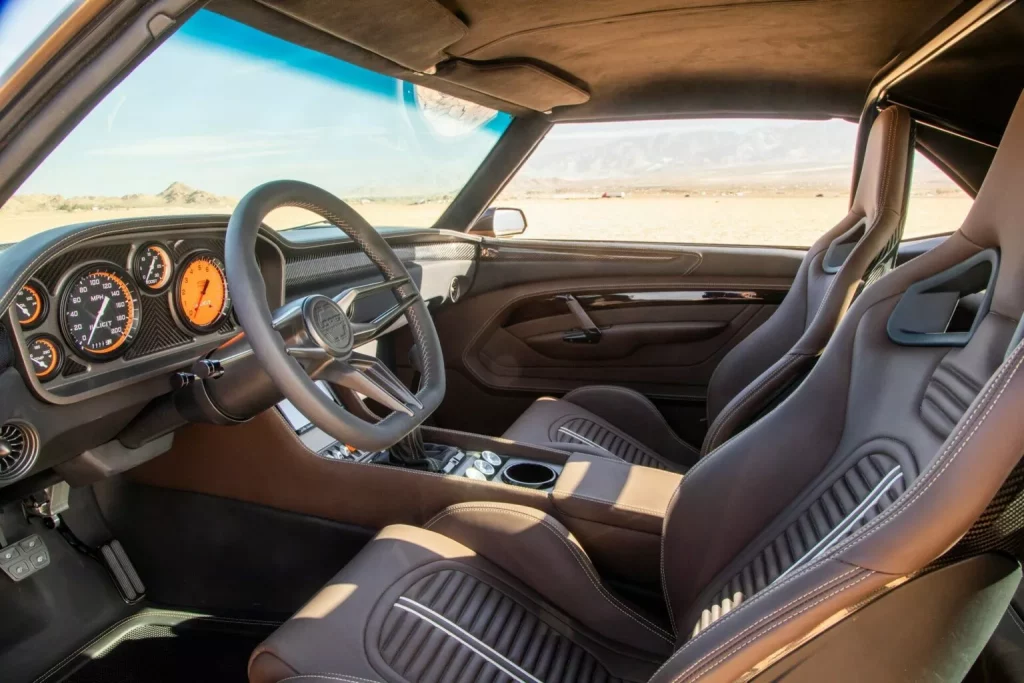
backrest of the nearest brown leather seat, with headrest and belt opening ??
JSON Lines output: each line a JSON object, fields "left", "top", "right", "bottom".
{"left": 654, "top": 92, "right": 1024, "bottom": 681}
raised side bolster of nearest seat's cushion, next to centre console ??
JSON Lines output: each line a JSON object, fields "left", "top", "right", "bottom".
{"left": 424, "top": 502, "right": 675, "bottom": 656}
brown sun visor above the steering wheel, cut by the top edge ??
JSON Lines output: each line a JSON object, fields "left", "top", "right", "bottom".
{"left": 259, "top": 0, "right": 468, "bottom": 72}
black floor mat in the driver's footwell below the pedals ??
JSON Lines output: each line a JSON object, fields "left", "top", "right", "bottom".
{"left": 37, "top": 609, "right": 276, "bottom": 683}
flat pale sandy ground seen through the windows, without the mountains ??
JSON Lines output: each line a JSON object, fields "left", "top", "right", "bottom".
{"left": 0, "top": 183, "right": 971, "bottom": 247}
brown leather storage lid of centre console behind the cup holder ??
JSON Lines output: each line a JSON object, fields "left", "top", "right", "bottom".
{"left": 551, "top": 454, "right": 683, "bottom": 536}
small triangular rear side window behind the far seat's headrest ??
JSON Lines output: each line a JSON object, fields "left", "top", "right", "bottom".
{"left": 903, "top": 152, "right": 974, "bottom": 240}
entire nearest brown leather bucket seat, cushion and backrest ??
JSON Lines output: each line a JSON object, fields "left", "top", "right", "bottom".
{"left": 249, "top": 94, "right": 1024, "bottom": 683}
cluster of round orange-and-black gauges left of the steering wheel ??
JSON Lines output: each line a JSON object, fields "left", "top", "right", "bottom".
{"left": 11, "top": 242, "right": 231, "bottom": 382}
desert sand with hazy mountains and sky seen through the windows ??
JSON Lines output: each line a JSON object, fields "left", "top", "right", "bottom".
{"left": 0, "top": 122, "right": 971, "bottom": 247}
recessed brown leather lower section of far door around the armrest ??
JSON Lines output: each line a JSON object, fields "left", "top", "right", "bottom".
{"left": 464, "top": 284, "right": 784, "bottom": 400}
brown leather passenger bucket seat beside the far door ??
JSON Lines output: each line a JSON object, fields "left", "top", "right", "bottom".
{"left": 504, "top": 105, "right": 913, "bottom": 471}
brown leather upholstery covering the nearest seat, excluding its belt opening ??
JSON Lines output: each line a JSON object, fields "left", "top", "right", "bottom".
{"left": 251, "top": 92, "right": 1024, "bottom": 683}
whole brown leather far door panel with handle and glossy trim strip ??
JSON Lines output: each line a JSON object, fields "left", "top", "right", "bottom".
{"left": 396, "top": 240, "right": 804, "bottom": 439}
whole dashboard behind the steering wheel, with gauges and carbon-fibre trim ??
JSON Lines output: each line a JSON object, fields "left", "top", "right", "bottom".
{"left": 0, "top": 215, "right": 481, "bottom": 497}
